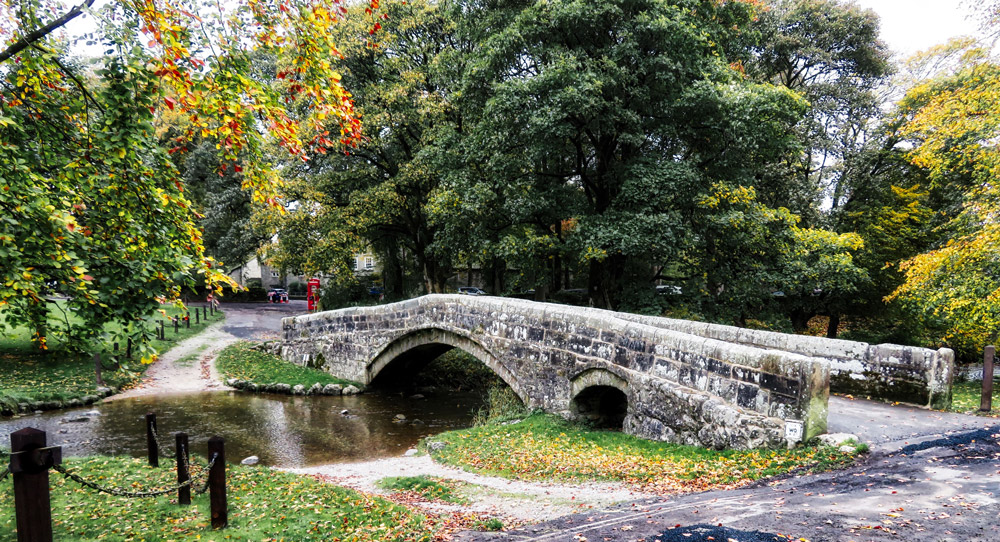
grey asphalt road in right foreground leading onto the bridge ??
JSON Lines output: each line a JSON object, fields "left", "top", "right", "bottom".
{"left": 459, "top": 398, "right": 1000, "bottom": 542}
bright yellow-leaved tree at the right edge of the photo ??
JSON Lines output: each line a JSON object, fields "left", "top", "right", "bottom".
{"left": 893, "top": 57, "right": 1000, "bottom": 354}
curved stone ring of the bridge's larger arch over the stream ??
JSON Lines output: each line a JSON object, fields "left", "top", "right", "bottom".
{"left": 365, "top": 327, "right": 530, "bottom": 405}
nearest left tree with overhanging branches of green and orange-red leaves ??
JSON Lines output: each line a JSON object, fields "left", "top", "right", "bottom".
{"left": 0, "top": 0, "right": 378, "bottom": 360}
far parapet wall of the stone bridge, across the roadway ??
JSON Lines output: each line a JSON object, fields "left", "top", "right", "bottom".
{"left": 610, "top": 313, "right": 955, "bottom": 409}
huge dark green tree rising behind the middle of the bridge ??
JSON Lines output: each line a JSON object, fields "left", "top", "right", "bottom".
{"left": 472, "top": 0, "right": 802, "bottom": 308}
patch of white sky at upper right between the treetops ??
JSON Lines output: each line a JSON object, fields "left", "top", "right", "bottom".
{"left": 855, "top": 0, "right": 978, "bottom": 57}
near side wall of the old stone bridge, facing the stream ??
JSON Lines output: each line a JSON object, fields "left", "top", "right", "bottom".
{"left": 280, "top": 294, "right": 830, "bottom": 448}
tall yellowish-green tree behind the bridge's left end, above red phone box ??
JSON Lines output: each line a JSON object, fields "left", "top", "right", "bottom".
{"left": 270, "top": 0, "right": 462, "bottom": 297}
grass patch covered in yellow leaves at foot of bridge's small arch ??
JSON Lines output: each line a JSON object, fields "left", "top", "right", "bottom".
{"left": 428, "top": 414, "right": 855, "bottom": 493}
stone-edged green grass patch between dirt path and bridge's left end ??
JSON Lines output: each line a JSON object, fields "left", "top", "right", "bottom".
{"left": 215, "top": 342, "right": 361, "bottom": 388}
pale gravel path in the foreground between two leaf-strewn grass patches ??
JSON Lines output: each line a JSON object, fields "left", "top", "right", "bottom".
{"left": 287, "top": 452, "right": 668, "bottom": 523}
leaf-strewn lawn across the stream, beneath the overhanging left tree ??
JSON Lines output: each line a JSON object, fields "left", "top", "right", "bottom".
{"left": 0, "top": 307, "right": 225, "bottom": 412}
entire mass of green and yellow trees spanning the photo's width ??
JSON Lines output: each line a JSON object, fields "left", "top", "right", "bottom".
{"left": 7, "top": 0, "right": 1000, "bottom": 368}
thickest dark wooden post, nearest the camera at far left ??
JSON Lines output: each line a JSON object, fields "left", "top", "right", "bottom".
{"left": 10, "top": 427, "right": 62, "bottom": 542}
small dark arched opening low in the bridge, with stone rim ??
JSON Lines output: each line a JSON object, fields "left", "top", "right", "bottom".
{"left": 570, "top": 369, "right": 629, "bottom": 430}
